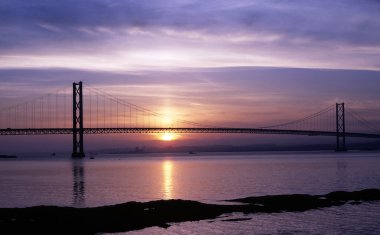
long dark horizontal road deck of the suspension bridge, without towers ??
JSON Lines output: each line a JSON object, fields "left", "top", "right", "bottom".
{"left": 0, "top": 127, "right": 380, "bottom": 139}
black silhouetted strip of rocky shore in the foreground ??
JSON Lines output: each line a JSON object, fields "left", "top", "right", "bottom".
{"left": 0, "top": 189, "right": 380, "bottom": 234}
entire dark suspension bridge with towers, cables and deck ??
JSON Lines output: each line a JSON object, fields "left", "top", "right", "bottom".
{"left": 0, "top": 82, "right": 380, "bottom": 157}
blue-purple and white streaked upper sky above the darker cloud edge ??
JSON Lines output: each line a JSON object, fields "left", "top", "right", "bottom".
{"left": 0, "top": 0, "right": 380, "bottom": 71}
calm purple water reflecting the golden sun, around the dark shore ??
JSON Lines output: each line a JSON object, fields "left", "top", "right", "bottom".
{"left": 0, "top": 152, "right": 380, "bottom": 234}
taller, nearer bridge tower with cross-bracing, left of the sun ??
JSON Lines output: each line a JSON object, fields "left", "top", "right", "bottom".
{"left": 71, "top": 82, "right": 84, "bottom": 158}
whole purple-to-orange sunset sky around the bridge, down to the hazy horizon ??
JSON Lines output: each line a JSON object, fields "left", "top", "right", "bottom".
{"left": 0, "top": 0, "right": 380, "bottom": 152}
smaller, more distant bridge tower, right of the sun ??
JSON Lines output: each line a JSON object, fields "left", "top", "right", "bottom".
{"left": 336, "top": 103, "right": 347, "bottom": 152}
